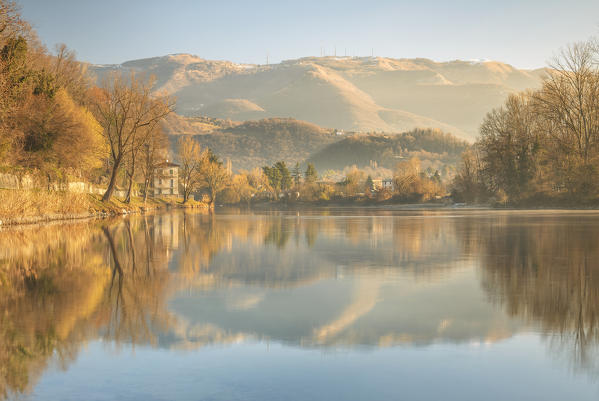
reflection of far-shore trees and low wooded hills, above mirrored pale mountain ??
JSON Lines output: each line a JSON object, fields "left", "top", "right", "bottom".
{"left": 175, "top": 215, "right": 466, "bottom": 287}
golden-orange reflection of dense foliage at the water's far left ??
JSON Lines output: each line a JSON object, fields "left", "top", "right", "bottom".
{"left": 0, "top": 224, "right": 108, "bottom": 397}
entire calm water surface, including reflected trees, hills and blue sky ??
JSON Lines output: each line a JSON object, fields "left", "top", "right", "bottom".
{"left": 0, "top": 209, "right": 599, "bottom": 401}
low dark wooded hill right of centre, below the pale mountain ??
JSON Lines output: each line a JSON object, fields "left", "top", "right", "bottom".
{"left": 307, "top": 129, "right": 468, "bottom": 171}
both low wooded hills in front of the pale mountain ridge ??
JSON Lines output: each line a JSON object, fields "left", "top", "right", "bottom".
{"left": 164, "top": 114, "right": 468, "bottom": 171}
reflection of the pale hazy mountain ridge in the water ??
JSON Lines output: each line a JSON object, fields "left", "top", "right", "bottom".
{"left": 171, "top": 260, "right": 519, "bottom": 347}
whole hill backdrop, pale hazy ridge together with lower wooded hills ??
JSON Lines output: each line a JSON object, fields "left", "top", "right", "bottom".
{"left": 91, "top": 54, "right": 545, "bottom": 169}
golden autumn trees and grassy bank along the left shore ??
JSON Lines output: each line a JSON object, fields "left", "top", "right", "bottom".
{"left": 0, "top": 0, "right": 224, "bottom": 222}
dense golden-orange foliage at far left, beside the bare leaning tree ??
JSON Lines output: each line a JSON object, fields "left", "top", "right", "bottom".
{"left": 0, "top": 0, "right": 103, "bottom": 188}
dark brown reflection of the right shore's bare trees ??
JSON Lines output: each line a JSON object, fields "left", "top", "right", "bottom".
{"left": 478, "top": 216, "right": 599, "bottom": 376}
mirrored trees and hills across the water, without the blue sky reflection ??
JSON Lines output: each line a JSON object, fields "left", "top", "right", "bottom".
{"left": 0, "top": 212, "right": 599, "bottom": 396}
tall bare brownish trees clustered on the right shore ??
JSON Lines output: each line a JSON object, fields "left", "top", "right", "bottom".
{"left": 452, "top": 39, "right": 599, "bottom": 207}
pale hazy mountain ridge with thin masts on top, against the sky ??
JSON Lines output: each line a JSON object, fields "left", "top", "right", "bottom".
{"left": 91, "top": 54, "right": 545, "bottom": 139}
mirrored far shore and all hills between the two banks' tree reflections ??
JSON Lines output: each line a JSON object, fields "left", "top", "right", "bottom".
{"left": 166, "top": 213, "right": 517, "bottom": 346}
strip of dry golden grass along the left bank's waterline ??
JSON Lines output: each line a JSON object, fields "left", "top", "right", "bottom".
{"left": 0, "top": 190, "right": 208, "bottom": 225}
